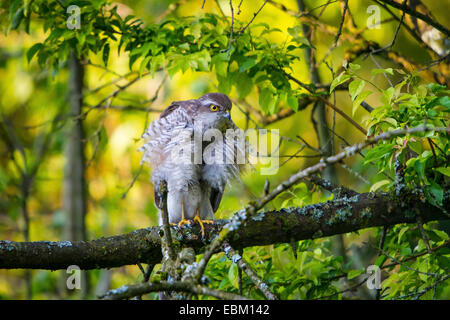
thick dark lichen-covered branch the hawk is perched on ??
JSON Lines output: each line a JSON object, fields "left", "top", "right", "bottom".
{"left": 0, "top": 192, "right": 450, "bottom": 270}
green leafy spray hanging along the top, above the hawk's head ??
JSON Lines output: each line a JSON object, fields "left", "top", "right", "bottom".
{"left": 11, "top": 1, "right": 310, "bottom": 114}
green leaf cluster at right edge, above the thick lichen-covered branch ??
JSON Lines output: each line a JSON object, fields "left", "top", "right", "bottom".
{"left": 331, "top": 64, "right": 450, "bottom": 206}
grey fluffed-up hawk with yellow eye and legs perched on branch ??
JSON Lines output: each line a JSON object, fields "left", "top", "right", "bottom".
{"left": 140, "top": 93, "right": 246, "bottom": 235}
